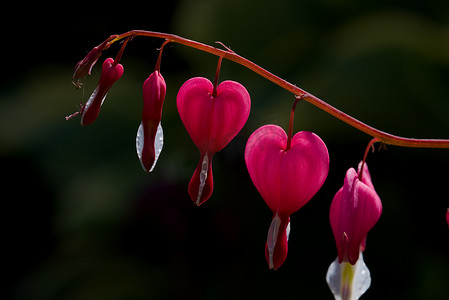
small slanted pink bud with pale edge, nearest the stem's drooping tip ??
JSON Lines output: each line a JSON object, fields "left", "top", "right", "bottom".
{"left": 81, "top": 58, "right": 123, "bottom": 126}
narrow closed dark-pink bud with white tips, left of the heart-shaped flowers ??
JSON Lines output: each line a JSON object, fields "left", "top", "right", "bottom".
{"left": 136, "top": 70, "right": 167, "bottom": 172}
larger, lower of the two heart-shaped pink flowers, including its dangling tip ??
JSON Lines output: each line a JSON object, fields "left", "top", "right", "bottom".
{"left": 245, "top": 125, "right": 329, "bottom": 269}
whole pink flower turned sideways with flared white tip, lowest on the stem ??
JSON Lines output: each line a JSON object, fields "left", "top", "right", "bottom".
{"left": 326, "top": 161, "right": 382, "bottom": 300}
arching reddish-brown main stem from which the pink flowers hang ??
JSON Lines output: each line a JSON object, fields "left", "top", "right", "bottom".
{"left": 93, "top": 30, "right": 449, "bottom": 148}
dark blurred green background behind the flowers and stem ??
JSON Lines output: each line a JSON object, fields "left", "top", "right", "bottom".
{"left": 0, "top": 0, "right": 449, "bottom": 300}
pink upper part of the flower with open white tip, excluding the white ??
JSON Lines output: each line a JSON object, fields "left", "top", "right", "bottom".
{"left": 329, "top": 162, "right": 382, "bottom": 265}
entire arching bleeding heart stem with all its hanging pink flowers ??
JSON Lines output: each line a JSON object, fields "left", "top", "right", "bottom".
{"left": 66, "top": 30, "right": 449, "bottom": 300}
